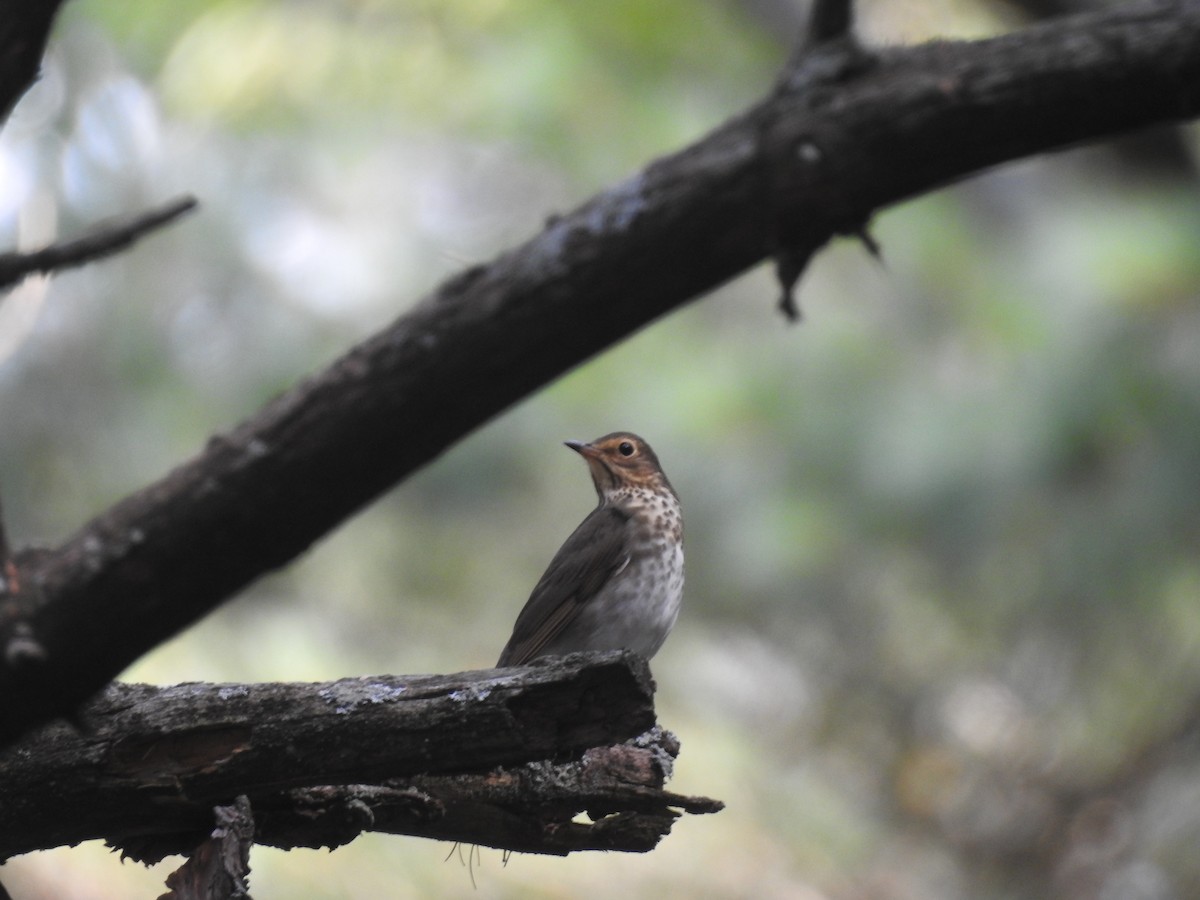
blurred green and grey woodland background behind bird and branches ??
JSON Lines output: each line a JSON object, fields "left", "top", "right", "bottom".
{"left": 0, "top": 0, "right": 1200, "bottom": 900}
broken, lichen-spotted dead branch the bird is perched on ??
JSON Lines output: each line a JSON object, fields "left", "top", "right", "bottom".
{"left": 0, "top": 653, "right": 720, "bottom": 860}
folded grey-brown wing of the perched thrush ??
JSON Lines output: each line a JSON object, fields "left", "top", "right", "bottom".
{"left": 496, "top": 506, "right": 629, "bottom": 666}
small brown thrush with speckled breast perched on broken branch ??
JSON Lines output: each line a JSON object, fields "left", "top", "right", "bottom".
{"left": 497, "top": 432, "right": 683, "bottom": 666}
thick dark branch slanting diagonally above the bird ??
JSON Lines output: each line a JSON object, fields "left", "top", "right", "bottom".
{"left": 0, "top": 0, "right": 1200, "bottom": 737}
